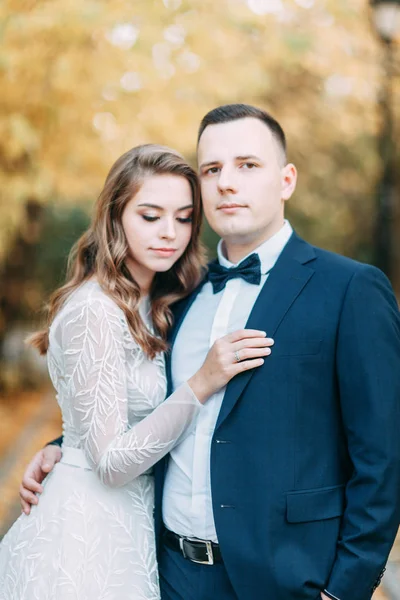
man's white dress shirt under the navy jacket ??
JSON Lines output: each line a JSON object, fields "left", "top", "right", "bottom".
{"left": 163, "top": 221, "right": 293, "bottom": 542}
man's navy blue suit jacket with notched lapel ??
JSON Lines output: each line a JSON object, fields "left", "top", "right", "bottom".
{"left": 155, "top": 234, "right": 400, "bottom": 600}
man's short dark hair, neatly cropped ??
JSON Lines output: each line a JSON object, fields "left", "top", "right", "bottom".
{"left": 197, "top": 104, "right": 286, "bottom": 161}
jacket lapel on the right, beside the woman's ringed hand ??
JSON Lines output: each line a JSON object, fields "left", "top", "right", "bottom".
{"left": 216, "top": 234, "right": 315, "bottom": 429}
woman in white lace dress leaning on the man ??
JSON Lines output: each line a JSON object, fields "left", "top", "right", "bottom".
{"left": 0, "top": 145, "right": 263, "bottom": 600}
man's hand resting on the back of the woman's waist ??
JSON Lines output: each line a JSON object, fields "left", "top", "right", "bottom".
{"left": 19, "top": 445, "right": 61, "bottom": 515}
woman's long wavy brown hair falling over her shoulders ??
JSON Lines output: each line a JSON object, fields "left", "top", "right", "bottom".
{"left": 27, "top": 144, "right": 205, "bottom": 358}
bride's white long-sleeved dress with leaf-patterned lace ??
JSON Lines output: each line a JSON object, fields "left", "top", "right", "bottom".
{"left": 0, "top": 281, "right": 201, "bottom": 600}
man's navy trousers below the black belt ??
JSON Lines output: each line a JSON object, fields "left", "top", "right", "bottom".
{"left": 158, "top": 546, "right": 237, "bottom": 600}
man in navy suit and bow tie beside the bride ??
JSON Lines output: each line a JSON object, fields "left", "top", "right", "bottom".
{"left": 21, "top": 104, "right": 400, "bottom": 600}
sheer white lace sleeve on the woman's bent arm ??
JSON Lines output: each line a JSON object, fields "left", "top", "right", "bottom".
{"left": 61, "top": 299, "right": 201, "bottom": 486}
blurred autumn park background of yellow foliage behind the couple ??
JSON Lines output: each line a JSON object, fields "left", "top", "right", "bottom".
{"left": 0, "top": 0, "right": 400, "bottom": 598}
